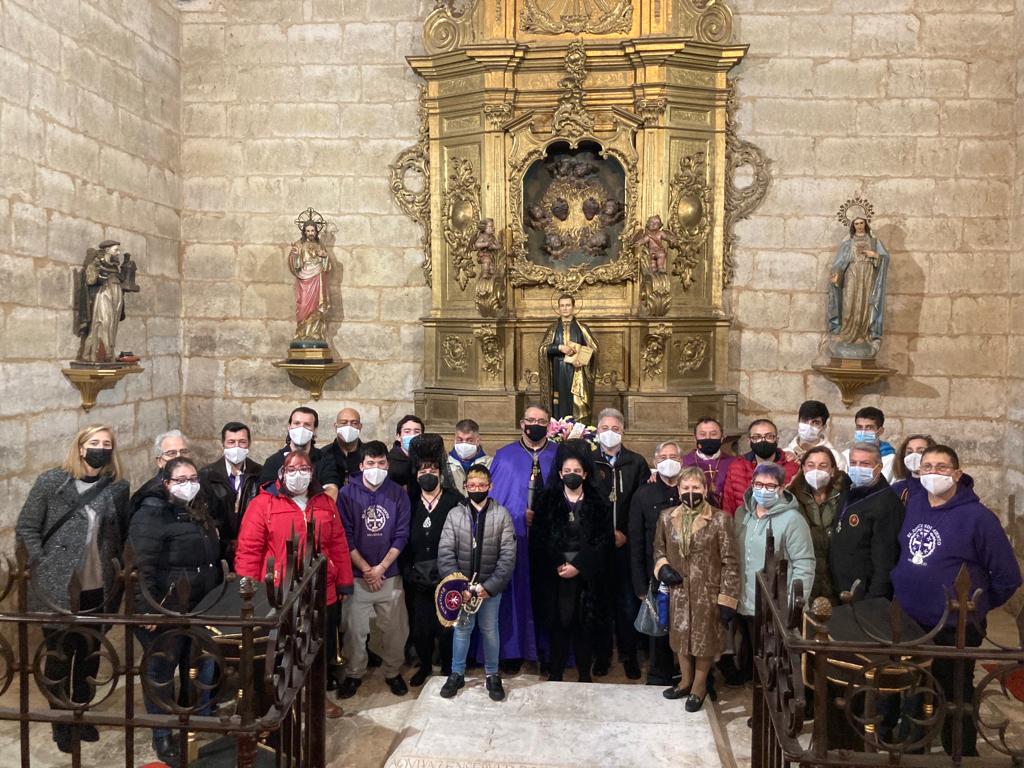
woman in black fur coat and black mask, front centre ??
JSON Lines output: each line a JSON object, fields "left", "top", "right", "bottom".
{"left": 529, "top": 440, "right": 614, "bottom": 683}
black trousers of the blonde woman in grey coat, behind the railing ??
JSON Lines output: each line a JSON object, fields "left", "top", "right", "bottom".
{"left": 43, "top": 589, "right": 103, "bottom": 730}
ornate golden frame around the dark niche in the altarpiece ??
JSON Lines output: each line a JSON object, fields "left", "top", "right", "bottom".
{"left": 508, "top": 108, "right": 643, "bottom": 293}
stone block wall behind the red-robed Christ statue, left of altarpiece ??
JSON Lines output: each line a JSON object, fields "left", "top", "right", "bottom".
{"left": 181, "top": 0, "right": 432, "bottom": 457}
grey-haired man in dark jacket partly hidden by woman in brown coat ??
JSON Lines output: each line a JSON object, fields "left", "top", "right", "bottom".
{"left": 629, "top": 442, "right": 683, "bottom": 685}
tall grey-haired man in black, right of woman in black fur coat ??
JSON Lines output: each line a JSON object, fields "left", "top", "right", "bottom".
{"left": 594, "top": 408, "right": 650, "bottom": 680}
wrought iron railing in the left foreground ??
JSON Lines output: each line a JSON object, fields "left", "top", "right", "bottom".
{"left": 0, "top": 527, "right": 327, "bottom": 768}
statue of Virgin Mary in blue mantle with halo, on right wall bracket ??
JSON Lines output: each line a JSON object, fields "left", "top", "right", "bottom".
{"left": 828, "top": 204, "right": 890, "bottom": 359}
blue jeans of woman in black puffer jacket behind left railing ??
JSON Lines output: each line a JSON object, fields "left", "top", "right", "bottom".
{"left": 135, "top": 627, "right": 216, "bottom": 739}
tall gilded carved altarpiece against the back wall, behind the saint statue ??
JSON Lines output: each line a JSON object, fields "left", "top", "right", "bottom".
{"left": 391, "top": 0, "right": 768, "bottom": 441}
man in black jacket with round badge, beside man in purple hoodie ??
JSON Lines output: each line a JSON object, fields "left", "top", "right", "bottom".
{"left": 828, "top": 442, "right": 904, "bottom": 599}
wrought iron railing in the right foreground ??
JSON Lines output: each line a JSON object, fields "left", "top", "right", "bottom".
{"left": 751, "top": 542, "right": 1024, "bottom": 768}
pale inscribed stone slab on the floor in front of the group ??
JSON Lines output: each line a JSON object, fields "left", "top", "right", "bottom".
{"left": 386, "top": 676, "right": 728, "bottom": 768}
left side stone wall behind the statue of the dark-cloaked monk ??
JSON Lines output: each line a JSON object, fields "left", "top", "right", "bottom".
{"left": 0, "top": 0, "right": 181, "bottom": 548}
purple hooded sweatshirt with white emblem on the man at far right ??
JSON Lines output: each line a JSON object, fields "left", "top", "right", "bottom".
{"left": 892, "top": 474, "right": 1021, "bottom": 630}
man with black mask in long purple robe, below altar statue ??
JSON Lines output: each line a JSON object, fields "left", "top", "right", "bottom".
{"left": 490, "top": 406, "right": 555, "bottom": 674}
